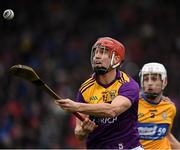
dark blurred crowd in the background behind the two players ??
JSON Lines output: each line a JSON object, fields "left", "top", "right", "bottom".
{"left": 0, "top": 0, "right": 180, "bottom": 148}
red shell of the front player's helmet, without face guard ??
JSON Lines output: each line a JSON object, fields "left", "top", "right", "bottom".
{"left": 93, "top": 37, "right": 125, "bottom": 61}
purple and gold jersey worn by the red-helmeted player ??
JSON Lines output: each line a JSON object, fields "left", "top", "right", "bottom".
{"left": 77, "top": 71, "right": 140, "bottom": 149}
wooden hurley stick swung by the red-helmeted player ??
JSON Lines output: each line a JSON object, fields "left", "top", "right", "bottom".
{"left": 10, "top": 65, "right": 84, "bottom": 121}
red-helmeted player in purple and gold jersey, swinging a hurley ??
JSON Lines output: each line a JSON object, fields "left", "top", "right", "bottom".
{"left": 56, "top": 37, "right": 143, "bottom": 150}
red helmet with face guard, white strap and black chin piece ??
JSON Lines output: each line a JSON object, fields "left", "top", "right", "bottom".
{"left": 91, "top": 37, "right": 125, "bottom": 74}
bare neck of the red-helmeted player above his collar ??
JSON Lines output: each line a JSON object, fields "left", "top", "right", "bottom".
{"left": 99, "top": 69, "right": 116, "bottom": 84}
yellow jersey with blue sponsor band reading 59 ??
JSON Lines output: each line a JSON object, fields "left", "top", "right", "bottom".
{"left": 138, "top": 95, "right": 176, "bottom": 150}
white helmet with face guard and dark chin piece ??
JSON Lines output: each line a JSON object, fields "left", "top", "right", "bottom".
{"left": 139, "top": 63, "right": 167, "bottom": 99}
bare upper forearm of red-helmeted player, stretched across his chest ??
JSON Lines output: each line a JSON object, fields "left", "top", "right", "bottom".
{"left": 78, "top": 103, "right": 117, "bottom": 117}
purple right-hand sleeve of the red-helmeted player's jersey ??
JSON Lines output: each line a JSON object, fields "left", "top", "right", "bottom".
{"left": 118, "top": 79, "right": 139, "bottom": 103}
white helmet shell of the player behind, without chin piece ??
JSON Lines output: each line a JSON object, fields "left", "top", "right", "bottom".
{"left": 139, "top": 62, "right": 167, "bottom": 89}
